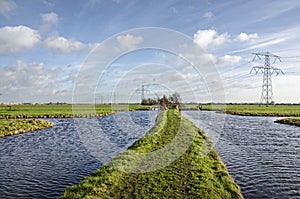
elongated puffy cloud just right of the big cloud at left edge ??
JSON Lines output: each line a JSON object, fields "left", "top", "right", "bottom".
{"left": 44, "top": 36, "right": 86, "bottom": 53}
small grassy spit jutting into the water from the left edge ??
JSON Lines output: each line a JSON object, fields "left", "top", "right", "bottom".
{"left": 0, "top": 120, "right": 54, "bottom": 137}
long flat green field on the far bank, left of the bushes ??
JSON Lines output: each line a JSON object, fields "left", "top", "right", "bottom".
{"left": 0, "top": 104, "right": 151, "bottom": 119}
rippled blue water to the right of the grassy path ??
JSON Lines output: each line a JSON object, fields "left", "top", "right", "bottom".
{"left": 183, "top": 111, "right": 300, "bottom": 199}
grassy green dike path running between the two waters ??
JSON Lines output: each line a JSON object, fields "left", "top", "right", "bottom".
{"left": 60, "top": 110, "right": 242, "bottom": 198}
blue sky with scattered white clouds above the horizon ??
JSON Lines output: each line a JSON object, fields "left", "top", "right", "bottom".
{"left": 0, "top": 0, "right": 300, "bottom": 103}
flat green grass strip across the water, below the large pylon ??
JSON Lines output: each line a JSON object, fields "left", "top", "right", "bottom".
{"left": 198, "top": 105, "right": 300, "bottom": 117}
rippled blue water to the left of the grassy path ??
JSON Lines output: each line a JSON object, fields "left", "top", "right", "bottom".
{"left": 0, "top": 111, "right": 157, "bottom": 198}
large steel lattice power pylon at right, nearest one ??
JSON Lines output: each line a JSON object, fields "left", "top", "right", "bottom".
{"left": 250, "top": 52, "right": 284, "bottom": 106}
